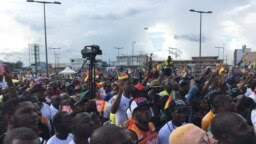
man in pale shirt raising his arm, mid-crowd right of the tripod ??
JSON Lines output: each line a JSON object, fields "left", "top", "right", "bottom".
{"left": 111, "top": 79, "right": 132, "bottom": 126}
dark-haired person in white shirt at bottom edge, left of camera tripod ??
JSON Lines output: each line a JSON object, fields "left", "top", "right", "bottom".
{"left": 47, "top": 112, "right": 73, "bottom": 144}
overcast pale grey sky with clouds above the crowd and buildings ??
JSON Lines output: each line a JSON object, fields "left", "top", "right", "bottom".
{"left": 0, "top": 0, "right": 256, "bottom": 63}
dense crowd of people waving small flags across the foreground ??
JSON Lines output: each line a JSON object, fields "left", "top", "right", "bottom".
{"left": 0, "top": 62, "right": 256, "bottom": 144}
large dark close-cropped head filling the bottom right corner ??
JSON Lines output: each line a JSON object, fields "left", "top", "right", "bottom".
{"left": 211, "top": 112, "right": 256, "bottom": 144}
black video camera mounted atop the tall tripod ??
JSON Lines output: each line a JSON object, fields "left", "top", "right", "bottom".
{"left": 81, "top": 45, "right": 102, "bottom": 58}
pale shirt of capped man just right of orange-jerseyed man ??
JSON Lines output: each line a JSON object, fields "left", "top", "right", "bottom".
{"left": 158, "top": 121, "right": 185, "bottom": 144}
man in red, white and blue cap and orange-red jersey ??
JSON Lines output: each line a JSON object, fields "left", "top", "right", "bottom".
{"left": 128, "top": 97, "right": 158, "bottom": 144}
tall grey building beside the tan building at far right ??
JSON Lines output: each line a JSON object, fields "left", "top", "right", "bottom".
{"left": 234, "top": 45, "right": 251, "bottom": 65}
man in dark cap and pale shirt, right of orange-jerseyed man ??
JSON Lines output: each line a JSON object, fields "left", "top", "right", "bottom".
{"left": 158, "top": 100, "right": 188, "bottom": 144}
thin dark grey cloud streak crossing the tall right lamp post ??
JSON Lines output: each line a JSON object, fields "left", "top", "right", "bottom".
{"left": 174, "top": 34, "right": 208, "bottom": 42}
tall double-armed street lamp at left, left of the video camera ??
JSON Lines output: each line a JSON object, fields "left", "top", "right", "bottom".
{"left": 27, "top": 0, "right": 61, "bottom": 77}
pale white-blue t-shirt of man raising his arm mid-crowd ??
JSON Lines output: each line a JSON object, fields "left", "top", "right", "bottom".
{"left": 113, "top": 95, "right": 131, "bottom": 126}
